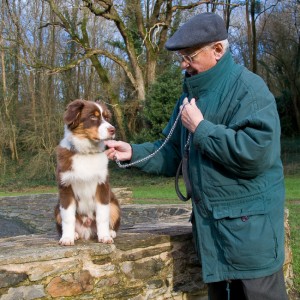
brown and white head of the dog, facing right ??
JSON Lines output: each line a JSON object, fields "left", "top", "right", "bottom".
{"left": 64, "top": 99, "right": 116, "bottom": 142}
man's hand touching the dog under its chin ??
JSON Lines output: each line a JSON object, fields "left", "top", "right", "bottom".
{"left": 104, "top": 140, "right": 132, "bottom": 161}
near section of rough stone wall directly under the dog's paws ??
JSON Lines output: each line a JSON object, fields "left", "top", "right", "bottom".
{"left": 0, "top": 228, "right": 206, "bottom": 300}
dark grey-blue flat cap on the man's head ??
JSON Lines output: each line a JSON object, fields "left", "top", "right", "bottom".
{"left": 165, "top": 13, "right": 228, "bottom": 51}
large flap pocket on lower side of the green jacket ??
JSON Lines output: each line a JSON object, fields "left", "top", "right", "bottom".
{"left": 213, "top": 202, "right": 277, "bottom": 270}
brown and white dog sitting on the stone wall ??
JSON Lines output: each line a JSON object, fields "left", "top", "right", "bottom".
{"left": 55, "top": 99, "right": 120, "bottom": 246}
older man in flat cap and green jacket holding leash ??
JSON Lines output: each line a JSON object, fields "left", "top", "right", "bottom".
{"left": 107, "top": 13, "right": 287, "bottom": 300}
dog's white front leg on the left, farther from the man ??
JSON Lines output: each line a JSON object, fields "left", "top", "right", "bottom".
{"left": 59, "top": 202, "right": 76, "bottom": 246}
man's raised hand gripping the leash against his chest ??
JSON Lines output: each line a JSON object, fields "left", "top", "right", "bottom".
{"left": 180, "top": 98, "right": 204, "bottom": 133}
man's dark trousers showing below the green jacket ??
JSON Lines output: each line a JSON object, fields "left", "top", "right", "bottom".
{"left": 208, "top": 269, "right": 288, "bottom": 300}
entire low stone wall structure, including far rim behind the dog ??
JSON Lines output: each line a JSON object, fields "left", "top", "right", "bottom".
{"left": 0, "top": 195, "right": 292, "bottom": 300}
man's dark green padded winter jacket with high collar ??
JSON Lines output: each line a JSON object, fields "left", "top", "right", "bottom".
{"left": 132, "top": 52, "right": 285, "bottom": 283}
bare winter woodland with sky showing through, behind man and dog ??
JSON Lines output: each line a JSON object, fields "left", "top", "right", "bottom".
{"left": 0, "top": 0, "right": 300, "bottom": 185}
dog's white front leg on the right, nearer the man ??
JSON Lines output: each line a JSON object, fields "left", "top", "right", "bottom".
{"left": 96, "top": 203, "right": 114, "bottom": 244}
